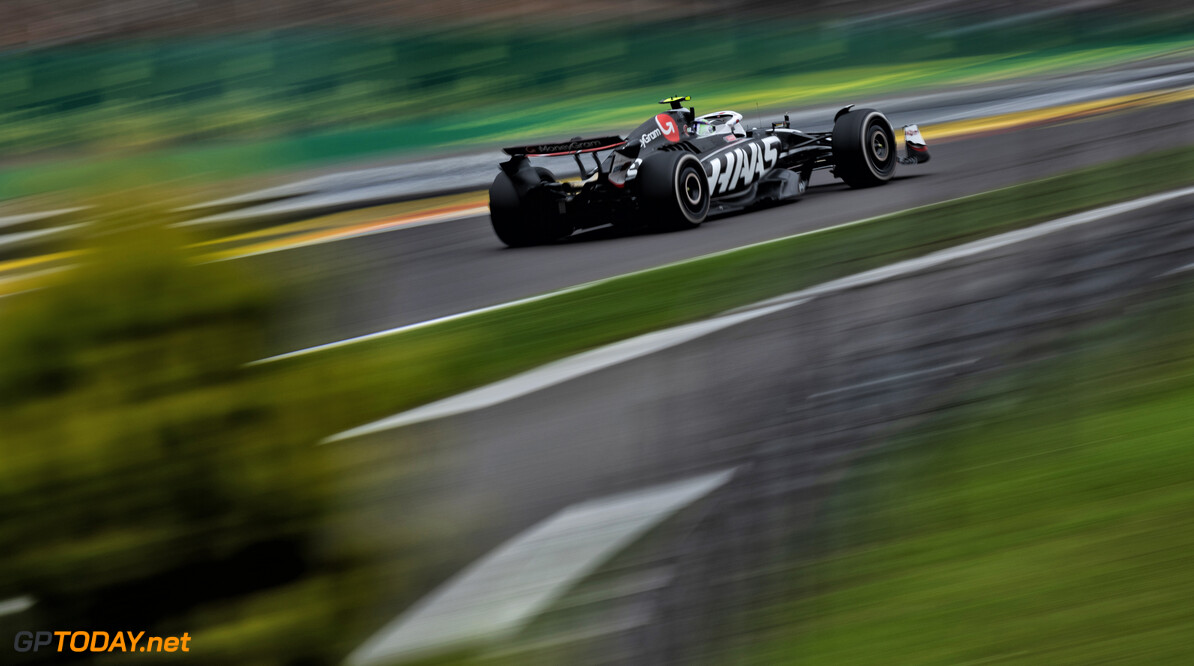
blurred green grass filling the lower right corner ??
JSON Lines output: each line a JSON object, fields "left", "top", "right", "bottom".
{"left": 736, "top": 264, "right": 1194, "bottom": 665}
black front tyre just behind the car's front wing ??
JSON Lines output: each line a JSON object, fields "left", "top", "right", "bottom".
{"left": 833, "top": 109, "right": 899, "bottom": 187}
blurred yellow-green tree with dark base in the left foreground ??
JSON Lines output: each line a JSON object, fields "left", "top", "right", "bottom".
{"left": 0, "top": 199, "right": 319, "bottom": 649}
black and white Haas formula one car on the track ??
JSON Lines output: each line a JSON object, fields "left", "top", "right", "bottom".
{"left": 490, "top": 97, "right": 929, "bottom": 247}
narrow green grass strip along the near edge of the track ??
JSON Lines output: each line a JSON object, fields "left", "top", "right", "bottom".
{"left": 263, "top": 149, "right": 1194, "bottom": 448}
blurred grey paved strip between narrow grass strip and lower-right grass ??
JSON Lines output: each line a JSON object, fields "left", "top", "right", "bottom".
{"left": 333, "top": 192, "right": 1194, "bottom": 664}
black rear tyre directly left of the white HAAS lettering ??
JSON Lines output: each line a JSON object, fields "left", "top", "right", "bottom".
{"left": 635, "top": 153, "right": 710, "bottom": 230}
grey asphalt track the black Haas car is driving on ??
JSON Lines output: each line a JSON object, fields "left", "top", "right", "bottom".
{"left": 256, "top": 101, "right": 1194, "bottom": 353}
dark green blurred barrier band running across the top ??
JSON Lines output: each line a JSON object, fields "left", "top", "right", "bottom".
{"left": 0, "top": 10, "right": 1190, "bottom": 133}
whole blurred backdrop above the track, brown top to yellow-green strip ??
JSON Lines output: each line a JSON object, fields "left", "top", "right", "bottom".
{"left": 0, "top": 1, "right": 1189, "bottom": 197}
